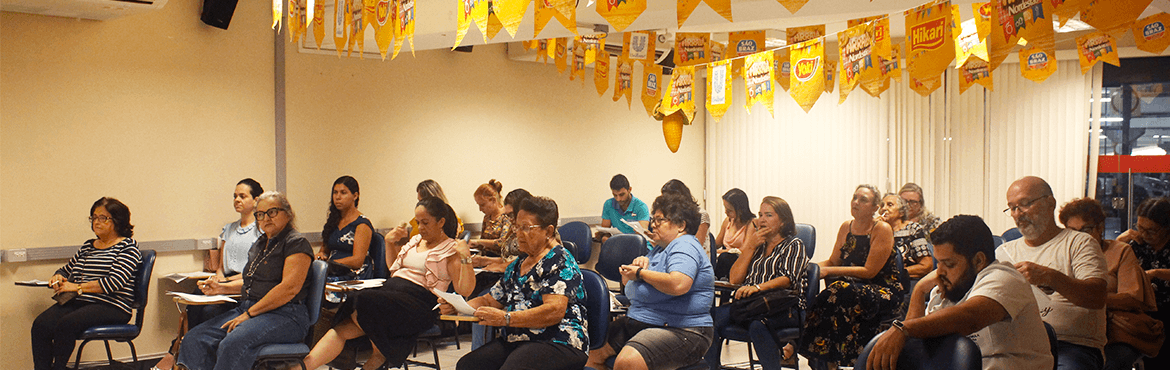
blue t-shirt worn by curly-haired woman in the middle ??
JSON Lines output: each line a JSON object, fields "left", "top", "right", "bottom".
{"left": 626, "top": 235, "right": 715, "bottom": 328}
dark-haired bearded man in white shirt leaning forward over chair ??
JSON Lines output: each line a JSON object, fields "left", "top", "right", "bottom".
{"left": 866, "top": 215, "right": 1053, "bottom": 370}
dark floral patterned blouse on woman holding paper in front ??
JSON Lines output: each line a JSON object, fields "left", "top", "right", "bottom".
{"left": 490, "top": 246, "right": 589, "bottom": 351}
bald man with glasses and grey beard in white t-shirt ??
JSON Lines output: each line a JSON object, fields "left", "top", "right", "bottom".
{"left": 996, "top": 176, "right": 1108, "bottom": 369}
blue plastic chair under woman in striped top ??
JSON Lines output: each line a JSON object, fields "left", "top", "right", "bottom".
{"left": 74, "top": 251, "right": 154, "bottom": 369}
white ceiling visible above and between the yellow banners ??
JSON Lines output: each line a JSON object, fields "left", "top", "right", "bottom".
{"left": 302, "top": 0, "right": 1170, "bottom": 54}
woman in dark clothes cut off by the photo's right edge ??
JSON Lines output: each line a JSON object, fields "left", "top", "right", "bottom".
{"left": 1129, "top": 197, "right": 1170, "bottom": 369}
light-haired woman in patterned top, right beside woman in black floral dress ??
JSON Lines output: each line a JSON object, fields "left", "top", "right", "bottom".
{"left": 879, "top": 193, "right": 935, "bottom": 279}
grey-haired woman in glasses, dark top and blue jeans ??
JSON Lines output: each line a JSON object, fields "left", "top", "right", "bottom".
{"left": 177, "top": 191, "right": 312, "bottom": 370}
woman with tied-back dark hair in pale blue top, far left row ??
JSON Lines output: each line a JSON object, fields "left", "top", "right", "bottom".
{"left": 154, "top": 178, "right": 264, "bottom": 369}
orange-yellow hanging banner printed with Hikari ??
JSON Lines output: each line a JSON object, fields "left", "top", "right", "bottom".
{"left": 904, "top": 1, "right": 955, "bottom": 88}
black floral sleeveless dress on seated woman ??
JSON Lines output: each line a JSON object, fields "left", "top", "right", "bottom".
{"left": 797, "top": 225, "right": 906, "bottom": 366}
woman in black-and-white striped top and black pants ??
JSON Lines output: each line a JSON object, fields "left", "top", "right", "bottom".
{"left": 32, "top": 198, "right": 142, "bottom": 370}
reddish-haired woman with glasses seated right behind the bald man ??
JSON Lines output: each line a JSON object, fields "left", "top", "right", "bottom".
{"left": 1059, "top": 198, "right": 1157, "bottom": 370}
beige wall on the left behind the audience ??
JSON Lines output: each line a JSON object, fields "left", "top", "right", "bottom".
{"left": 0, "top": 0, "right": 704, "bottom": 369}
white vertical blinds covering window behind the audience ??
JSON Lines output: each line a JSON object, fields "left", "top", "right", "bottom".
{"left": 706, "top": 61, "right": 1100, "bottom": 260}
